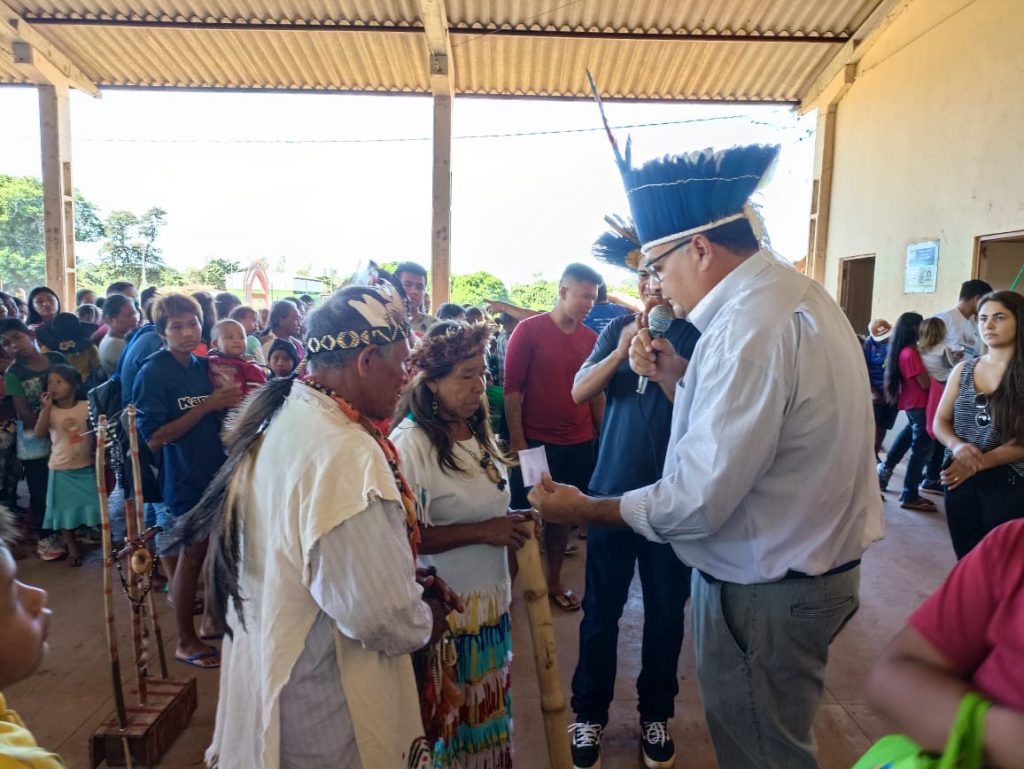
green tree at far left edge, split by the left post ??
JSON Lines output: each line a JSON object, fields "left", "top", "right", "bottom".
{"left": 0, "top": 174, "right": 102, "bottom": 291}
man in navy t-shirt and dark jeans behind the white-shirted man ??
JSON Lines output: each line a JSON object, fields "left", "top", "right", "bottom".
{"left": 570, "top": 218, "right": 699, "bottom": 769}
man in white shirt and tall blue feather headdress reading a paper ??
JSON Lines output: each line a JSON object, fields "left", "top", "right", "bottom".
{"left": 530, "top": 146, "right": 883, "bottom": 769}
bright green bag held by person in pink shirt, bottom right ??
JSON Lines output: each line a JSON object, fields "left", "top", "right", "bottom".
{"left": 853, "top": 692, "right": 991, "bottom": 769}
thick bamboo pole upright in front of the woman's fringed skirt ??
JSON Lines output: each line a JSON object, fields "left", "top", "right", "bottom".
{"left": 515, "top": 533, "right": 572, "bottom": 769}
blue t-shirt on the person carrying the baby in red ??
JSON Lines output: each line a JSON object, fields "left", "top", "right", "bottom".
{"left": 132, "top": 350, "right": 225, "bottom": 517}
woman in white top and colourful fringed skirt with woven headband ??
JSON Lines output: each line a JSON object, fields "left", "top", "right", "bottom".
{"left": 391, "top": 321, "right": 532, "bottom": 769}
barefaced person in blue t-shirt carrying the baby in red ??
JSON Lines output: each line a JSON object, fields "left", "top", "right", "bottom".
{"left": 132, "top": 294, "right": 242, "bottom": 669}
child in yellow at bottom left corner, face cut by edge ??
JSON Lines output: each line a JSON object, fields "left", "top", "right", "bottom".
{"left": 0, "top": 509, "right": 65, "bottom": 769}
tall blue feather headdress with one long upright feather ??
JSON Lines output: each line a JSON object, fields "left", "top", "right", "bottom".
{"left": 587, "top": 72, "right": 780, "bottom": 253}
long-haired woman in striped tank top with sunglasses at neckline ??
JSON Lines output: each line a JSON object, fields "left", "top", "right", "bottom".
{"left": 933, "top": 291, "right": 1024, "bottom": 558}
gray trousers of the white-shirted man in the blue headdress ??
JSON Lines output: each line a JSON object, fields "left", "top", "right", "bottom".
{"left": 691, "top": 566, "right": 860, "bottom": 769}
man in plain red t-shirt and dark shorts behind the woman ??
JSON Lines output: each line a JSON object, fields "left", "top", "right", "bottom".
{"left": 505, "top": 263, "right": 604, "bottom": 611}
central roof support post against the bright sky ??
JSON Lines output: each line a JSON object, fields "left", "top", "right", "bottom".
{"left": 430, "top": 94, "right": 452, "bottom": 310}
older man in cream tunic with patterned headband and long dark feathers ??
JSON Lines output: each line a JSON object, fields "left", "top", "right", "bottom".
{"left": 168, "top": 286, "right": 461, "bottom": 769}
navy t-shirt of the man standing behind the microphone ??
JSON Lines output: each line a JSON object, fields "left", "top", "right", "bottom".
{"left": 585, "top": 315, "right": 700, "bottom": 497}
